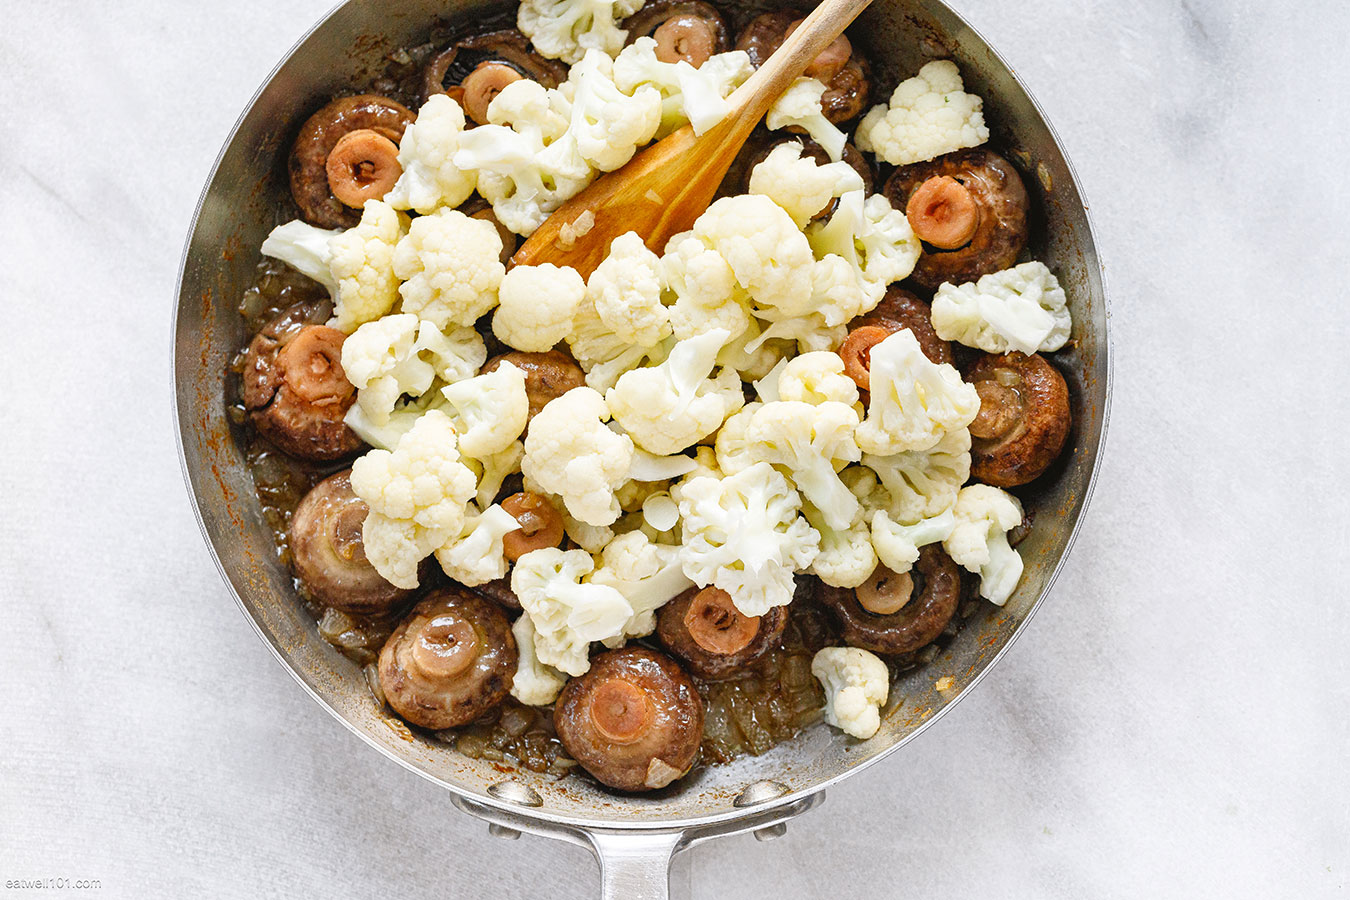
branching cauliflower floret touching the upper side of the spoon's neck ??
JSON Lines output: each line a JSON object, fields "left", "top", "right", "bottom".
{"left": 614, "top": 35, "right": 755, "bottom": 138}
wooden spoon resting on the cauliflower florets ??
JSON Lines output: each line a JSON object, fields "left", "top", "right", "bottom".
{"left": 512, "top": 0, "right": 871, "bottom": 278}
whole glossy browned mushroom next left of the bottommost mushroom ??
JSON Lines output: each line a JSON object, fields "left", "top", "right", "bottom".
{"left": 379, "top": 586, "right": 517, "bottom": 730}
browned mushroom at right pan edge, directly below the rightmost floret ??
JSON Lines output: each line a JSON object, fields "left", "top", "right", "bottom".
{"left": 965, "top": 352, "right": 1071, "bottom": 487}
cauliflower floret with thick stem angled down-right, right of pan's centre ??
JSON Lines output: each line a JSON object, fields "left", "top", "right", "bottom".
{"left": 745, "top": 401, "right": 861, "bottom": 529}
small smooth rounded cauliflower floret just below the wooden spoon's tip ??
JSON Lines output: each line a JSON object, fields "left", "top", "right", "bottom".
{"left": 493, "top": 263, "right": 586, "bottom": 352}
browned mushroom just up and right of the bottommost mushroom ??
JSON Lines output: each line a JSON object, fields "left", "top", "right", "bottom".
{"left": 656, "top": 587, "right": 787, "bottom": 681}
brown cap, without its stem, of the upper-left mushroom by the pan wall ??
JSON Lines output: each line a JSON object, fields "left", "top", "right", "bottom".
{"left": 290, "top": 93, "right": 417, "bottom": 228}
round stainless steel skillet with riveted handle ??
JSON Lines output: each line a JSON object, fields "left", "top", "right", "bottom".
{"left": 174, "top": 0, "right": 1111, "bottom": 899}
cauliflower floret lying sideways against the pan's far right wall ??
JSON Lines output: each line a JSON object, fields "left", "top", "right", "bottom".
{"left": 933, "top": 263, "right": 1073, "bottom": 356}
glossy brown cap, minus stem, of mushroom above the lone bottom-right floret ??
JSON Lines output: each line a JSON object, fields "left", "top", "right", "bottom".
{"left": 819, "top": 544, "right": 961, "bottom": 653}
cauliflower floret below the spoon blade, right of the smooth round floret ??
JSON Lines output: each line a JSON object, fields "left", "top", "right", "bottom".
{"left": 586, "top": 231, "right": 671, "bottom": 347}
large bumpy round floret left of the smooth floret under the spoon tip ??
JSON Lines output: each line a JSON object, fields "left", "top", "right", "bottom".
{"left": 394, "top": 209, "right": 506, "bottom": 328}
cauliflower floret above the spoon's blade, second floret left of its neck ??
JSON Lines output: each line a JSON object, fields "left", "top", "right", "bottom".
{"left": 560, "top": 50, "right": 662, "bottom": 171}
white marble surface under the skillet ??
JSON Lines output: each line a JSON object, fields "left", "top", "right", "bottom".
{"left": 0, "top": 0, "right": 1350, "bottom": 900}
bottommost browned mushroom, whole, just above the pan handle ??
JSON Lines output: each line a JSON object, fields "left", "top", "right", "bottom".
{"left": 554, "top": 646, "right": 703, "bottom": 791}
